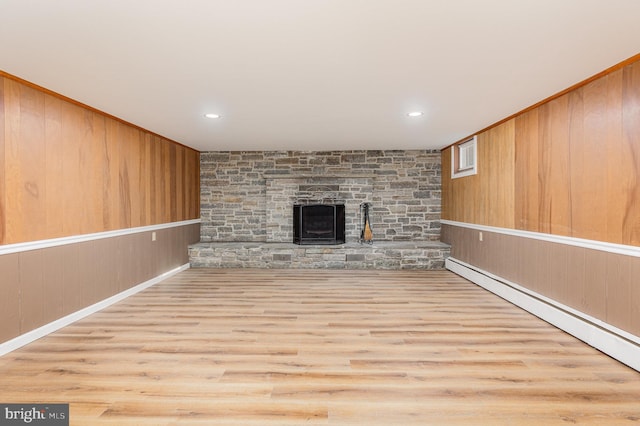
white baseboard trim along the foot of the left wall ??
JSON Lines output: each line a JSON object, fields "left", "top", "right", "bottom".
{"left": 0, "top": 263, "right": 189, "bottom": 356}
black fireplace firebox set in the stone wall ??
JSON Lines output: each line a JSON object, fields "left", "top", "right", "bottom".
{"left": 293, "top": 204, "right": 345, "bottom": 245}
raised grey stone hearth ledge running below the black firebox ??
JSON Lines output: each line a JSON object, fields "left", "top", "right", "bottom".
{"left": 189, "top": 241, "right": 449, "bottom": 269}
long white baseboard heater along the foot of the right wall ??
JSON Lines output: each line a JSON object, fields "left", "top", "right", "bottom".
{"left": 445, "top": 258, "right": 640, "bottom": 371}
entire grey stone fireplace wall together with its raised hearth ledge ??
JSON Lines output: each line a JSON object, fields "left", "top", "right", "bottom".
{"left": 189, "top": 150, "right": 449, "bottom": 269}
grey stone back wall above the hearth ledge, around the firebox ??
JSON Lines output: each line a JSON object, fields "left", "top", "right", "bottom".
{"left": 200, "top": 150, "right": 441, "bottom": 242}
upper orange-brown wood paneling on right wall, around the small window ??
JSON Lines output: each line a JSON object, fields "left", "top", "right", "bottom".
{"left": 442, "top": 61, "right": 640, "bottom": 245}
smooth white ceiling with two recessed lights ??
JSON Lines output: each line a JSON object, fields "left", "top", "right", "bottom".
{"left": 0, "top": 0, "right": 640, "bottom": 151}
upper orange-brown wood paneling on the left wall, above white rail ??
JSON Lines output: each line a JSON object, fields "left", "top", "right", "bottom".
{"left": 0, "top": 74, "right": 200, "bottom": 244}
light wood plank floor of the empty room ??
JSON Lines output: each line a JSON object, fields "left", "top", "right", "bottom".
{"left": 0, "top": 269, "right": 640, "bottom": 425}
